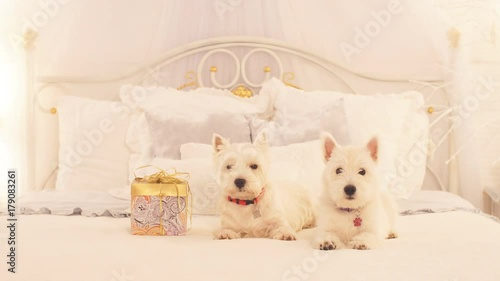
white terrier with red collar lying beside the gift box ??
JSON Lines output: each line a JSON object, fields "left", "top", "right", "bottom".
{"left": 213, "top": 134, "right": 315, "bottom": 240}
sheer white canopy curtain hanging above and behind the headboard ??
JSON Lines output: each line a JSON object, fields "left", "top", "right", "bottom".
{"left": 0, "top": 0, "right": 481, "bottom": 206}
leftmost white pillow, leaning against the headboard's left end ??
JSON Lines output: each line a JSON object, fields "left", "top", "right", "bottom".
{"left": 56, "top": 96, "right": 130, "bottom": 191}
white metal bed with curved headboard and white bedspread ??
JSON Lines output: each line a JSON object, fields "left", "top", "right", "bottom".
{"left": 0, "top": 30, "right": 500, "bottom": 281}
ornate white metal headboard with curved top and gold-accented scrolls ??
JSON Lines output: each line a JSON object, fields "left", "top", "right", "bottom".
{"left": 25, "top": 31, "right": 460, "bottom": 192}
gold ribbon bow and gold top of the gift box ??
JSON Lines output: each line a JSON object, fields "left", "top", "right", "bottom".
{"left": 131, "top": 165, "right": 193, "bottom": 235}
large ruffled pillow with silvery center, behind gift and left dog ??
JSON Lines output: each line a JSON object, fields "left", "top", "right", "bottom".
{"left": 120, "top": 85, "right": 268, "bottom": 173}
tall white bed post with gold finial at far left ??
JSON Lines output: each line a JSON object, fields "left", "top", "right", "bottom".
{"left": 20, "top": 29, "right": 38, "bottom": 190}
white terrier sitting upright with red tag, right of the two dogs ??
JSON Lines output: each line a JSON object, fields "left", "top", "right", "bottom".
{"left": 314, "top": 133, "right": 397, "bottom": 250}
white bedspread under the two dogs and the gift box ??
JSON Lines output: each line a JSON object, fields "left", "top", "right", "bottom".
{"left": 0, "top": 211, "right": 500, "bottom": 281}
